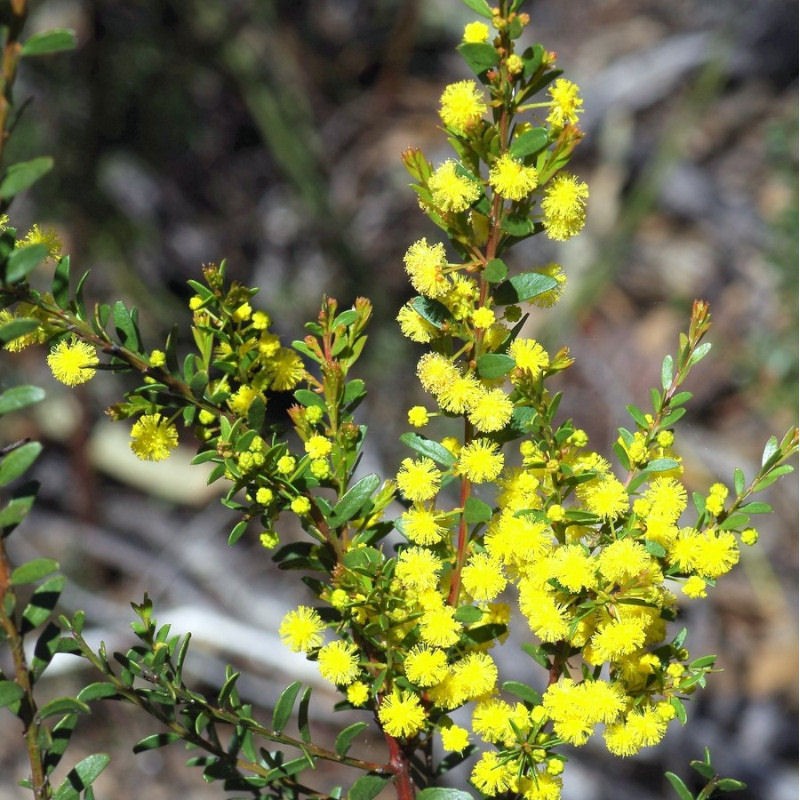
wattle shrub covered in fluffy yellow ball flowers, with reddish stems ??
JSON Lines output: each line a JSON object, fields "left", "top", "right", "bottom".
{"left": 0, "top": 0, "right": 797, "bottom": 800}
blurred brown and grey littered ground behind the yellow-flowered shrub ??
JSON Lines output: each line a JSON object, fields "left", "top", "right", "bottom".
{"left": 0, "top": 0, "right": 798, "bottom": 800}
